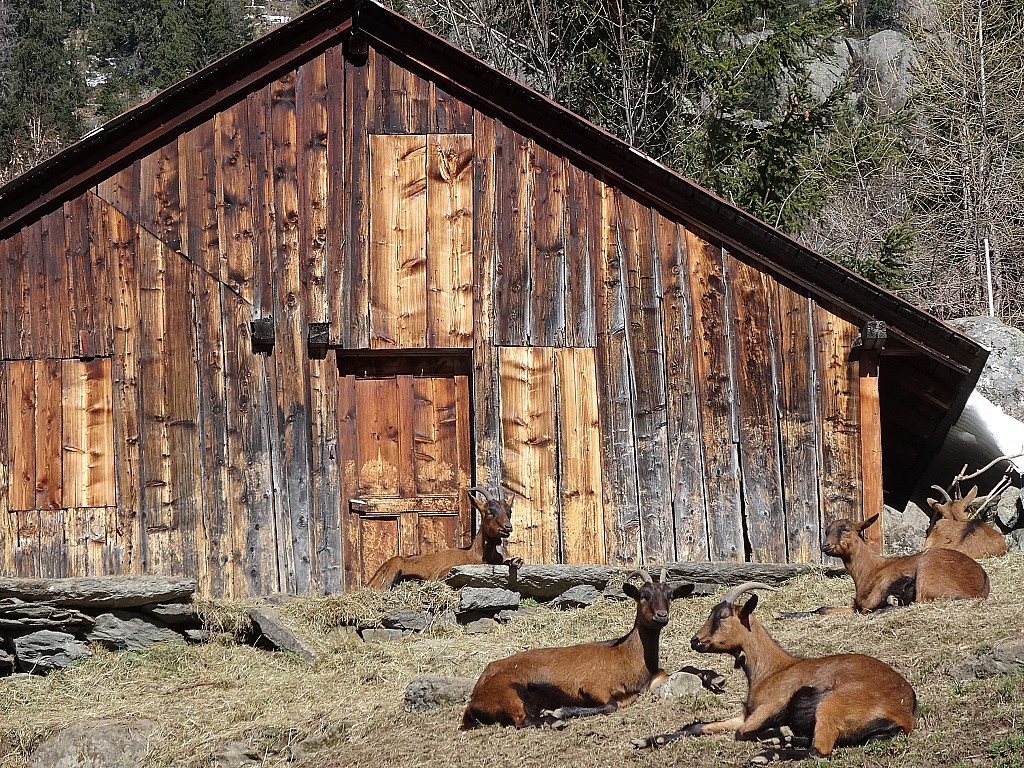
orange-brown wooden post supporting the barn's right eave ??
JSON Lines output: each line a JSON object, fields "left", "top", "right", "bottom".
{"left": 853, "top": 321, "right": 886, "bottom": 552}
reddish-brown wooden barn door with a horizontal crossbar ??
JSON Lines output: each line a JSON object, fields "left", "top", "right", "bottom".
{"left": 338, "top": 375, "right": 472, "bottom": 589}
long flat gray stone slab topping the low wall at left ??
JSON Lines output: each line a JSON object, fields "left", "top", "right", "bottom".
{"left": 0, "top": 575, "right": 196, "bottom": 608}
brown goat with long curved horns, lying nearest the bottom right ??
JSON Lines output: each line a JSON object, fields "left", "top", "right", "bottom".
{"left": 633, "top": 582, "right": 918, "bottom": 763}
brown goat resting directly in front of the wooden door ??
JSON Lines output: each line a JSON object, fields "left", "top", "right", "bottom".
{"left": 367, "top": 487, "right": 522, "bottom": 589}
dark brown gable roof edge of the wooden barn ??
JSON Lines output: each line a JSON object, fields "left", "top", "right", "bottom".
{"left": 0, "top": 0, "right": 988, "bottom": 499}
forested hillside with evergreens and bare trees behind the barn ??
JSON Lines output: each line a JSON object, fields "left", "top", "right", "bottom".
{"left": 0, "top": 0, "right": 1024, "bottom": 328}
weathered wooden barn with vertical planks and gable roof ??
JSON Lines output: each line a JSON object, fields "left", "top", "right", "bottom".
{"left": 0, "top": 0, "right": 987, "bottom": 597}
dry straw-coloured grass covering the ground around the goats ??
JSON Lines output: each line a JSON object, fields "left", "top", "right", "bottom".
{"left": 0, "top": 555, "right": 1024, "bottom": 768}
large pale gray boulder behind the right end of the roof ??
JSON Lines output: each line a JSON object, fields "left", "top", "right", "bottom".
{"left": 947, "top": 317, "right": 1024, "bottom": 421}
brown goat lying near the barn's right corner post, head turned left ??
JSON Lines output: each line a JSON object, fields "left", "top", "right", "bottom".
{"left": 782, "top": 515, "right": 989, "bottom": 618}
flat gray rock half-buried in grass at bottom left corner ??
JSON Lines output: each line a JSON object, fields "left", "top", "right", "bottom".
{"left": 29, "top": 720, "right": 159, "bottom": 768}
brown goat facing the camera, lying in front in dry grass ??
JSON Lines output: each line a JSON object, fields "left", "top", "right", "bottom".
{"left": 462, "top": 570, "right": 724, "bottom": 729}
